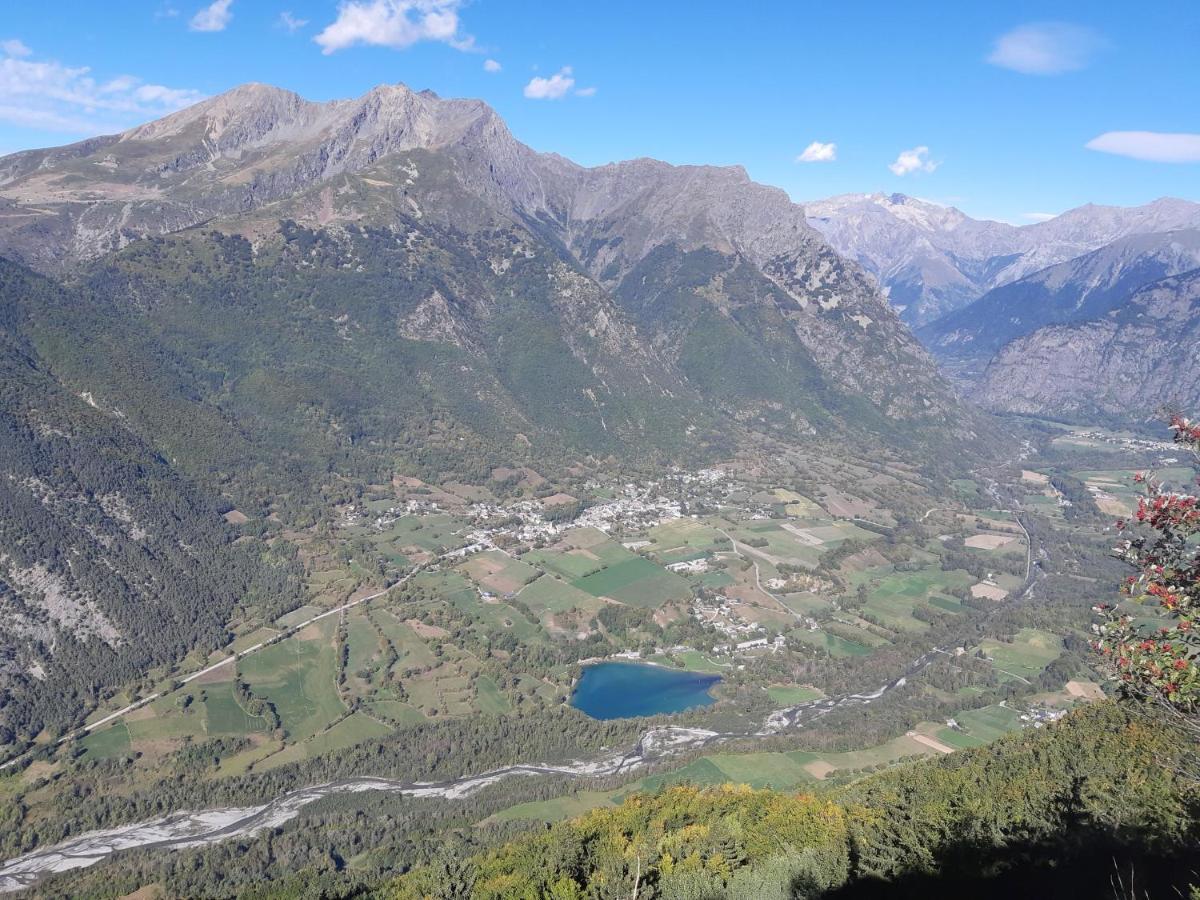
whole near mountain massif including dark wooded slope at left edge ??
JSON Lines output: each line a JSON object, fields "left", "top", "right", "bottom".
{"left": 0, "top": 84, "right": 985, "bottom": 738}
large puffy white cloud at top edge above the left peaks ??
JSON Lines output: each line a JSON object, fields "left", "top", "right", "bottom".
{"left": 313, "top": 0, "right": 474, "bottom": 55}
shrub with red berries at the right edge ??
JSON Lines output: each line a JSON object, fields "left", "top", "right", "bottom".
{"left": 1093, "top": 416, "right": 1200, "bottom": 716}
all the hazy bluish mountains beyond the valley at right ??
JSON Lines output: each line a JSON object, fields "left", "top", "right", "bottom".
{"left": 806, "top": 194, "right": 1200, "bottom": 420}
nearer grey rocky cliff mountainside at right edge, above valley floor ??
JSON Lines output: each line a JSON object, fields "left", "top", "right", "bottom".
{"left": 973, "top": 270, "right": 1200, "bottom": 420}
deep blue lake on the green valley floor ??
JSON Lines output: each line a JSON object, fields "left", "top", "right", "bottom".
{"left": 571, "top": 662, "right": 721, "bottom": 719}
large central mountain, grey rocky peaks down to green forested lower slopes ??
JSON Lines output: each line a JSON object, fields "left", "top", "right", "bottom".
{"left": 0, "top": 85, "right": 982, "bottom": 490}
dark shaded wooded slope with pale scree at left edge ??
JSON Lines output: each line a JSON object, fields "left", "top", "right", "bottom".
{"left": 0, "top": 260, "right": 304, "bottom": 744}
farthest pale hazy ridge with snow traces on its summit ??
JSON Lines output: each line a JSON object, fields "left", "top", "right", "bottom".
{"left": 805, "top": 193, "right": 1200, "bottom": 325}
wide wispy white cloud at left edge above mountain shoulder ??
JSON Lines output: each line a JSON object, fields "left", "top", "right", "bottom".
{"left": 0, "top": 44, "right": 204, "bottom": 134}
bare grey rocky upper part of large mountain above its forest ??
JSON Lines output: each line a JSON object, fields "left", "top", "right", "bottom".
{"left": 0, "top": 85, "right": 956, "bottom": 448}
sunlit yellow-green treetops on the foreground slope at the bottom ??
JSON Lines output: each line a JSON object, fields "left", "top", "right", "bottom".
{"left": 382, "top": 703, "right": 1200, "bottom": 900}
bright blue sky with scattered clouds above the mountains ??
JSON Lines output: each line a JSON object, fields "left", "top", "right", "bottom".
{"left": 0, "top": 0, "right": 1200, "bottom": 223}
